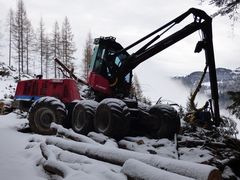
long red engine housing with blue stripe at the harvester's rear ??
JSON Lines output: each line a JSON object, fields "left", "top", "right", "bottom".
{"left": 15, "top": 79, "right": 80, "bottom": 103}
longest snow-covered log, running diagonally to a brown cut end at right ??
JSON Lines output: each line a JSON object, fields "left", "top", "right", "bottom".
{"left": 46, "top": 137, "right": 221, "bottom": 180}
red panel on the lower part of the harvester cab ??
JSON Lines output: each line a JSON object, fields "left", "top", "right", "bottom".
{"left": 88, "top": 72, "right": 111, "bottom": 95}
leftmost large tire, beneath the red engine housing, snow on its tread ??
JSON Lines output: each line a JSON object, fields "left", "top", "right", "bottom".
{"left": 28, "top": 96, "right": 66, "bottom": 135}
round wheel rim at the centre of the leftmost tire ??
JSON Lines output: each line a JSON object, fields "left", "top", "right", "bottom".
{"left": 35, "top": 108, "right": 56, "bottom": 128}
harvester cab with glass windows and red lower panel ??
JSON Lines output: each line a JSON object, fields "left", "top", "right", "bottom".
{"left": 88, "top": 37, "right": 132, "bottom": 99}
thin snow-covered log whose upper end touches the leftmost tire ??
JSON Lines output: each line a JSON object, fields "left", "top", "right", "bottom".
{"left": 51, "top": 123, "right": 99, "bottom": 145}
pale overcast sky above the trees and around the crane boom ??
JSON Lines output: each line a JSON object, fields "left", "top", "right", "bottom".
{"left": 0, "top": 0, "right": 240, "bottom": 101}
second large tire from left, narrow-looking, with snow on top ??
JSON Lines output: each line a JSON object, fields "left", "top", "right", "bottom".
{"left": 72, "top": 100, "right": 98, "bottom": 134}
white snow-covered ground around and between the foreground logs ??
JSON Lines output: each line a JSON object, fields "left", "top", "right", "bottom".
{"left": 0, "top": 113, "right": 225, "bottom": 180}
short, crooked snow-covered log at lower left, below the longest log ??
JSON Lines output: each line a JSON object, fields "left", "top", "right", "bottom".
{"left": 40, "top": 143, "right": 71, "bottom": 178}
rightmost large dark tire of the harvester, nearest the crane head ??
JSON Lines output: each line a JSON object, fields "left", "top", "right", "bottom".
{"left": 149, "top": 104, "right": 180, "bottom": 139}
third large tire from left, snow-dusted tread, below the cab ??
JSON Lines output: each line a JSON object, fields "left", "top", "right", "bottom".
{"left": 94, "top": 98, "right": 130, "bottom": 138}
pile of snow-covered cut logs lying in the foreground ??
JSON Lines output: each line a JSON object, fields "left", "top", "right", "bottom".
{"left": 32, "top": 124, "right": 229, "bottom": 180}
